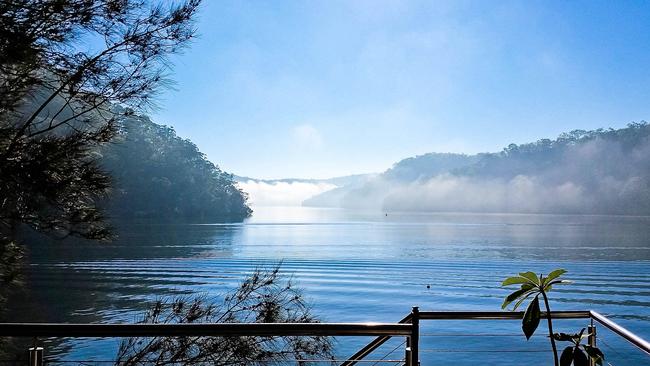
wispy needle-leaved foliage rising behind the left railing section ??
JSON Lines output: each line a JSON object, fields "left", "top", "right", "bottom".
{"left": 115, "top": 266, "right": 333, "bottom": 365}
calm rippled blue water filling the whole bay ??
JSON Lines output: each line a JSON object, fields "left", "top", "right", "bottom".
{"left": 7, "top": 208, "right": 650, "bottom": 365}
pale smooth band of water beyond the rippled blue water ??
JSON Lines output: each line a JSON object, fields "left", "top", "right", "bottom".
{"left": 238, "top": 208, "right": 650, "bottom": 261}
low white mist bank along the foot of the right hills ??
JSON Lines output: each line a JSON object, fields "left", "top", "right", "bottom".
{"left": 341, "top": 174, "right": 650, "bottom": 214}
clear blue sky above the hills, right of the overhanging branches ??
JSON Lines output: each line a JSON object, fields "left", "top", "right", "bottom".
{"left": 153, "top": 0, "right": 650, "bottom": 178}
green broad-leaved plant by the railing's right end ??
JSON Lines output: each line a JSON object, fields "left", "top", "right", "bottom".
{"left": 501, "top": 269, "right": 604, "bottom": 366}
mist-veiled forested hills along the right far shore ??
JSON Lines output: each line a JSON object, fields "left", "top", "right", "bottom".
{"left": 305, "top": 122, "right": 650, "bottom": 215}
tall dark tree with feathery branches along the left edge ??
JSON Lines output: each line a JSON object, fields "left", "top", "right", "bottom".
{"left": 0, "top": 0, "right": 200, "bottom": 306}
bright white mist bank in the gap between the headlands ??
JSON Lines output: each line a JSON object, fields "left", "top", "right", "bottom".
{"left": 238, "top": 180, "right": 337, "bottom": 206}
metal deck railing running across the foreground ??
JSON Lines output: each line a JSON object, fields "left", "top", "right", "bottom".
{"left": 0, "top": 307, "right": 650, "bottom": 366}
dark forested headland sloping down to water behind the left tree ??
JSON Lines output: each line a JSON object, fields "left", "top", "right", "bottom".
{"left": 100, "top": 115, "right": 251, "bottom": 220}
